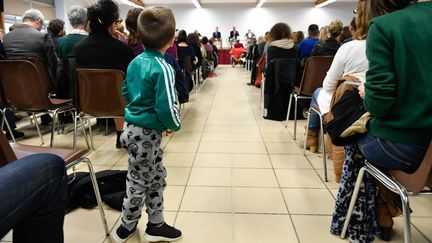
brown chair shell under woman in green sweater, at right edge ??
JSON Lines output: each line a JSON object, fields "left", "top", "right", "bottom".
{"left": 389, "top": 142, "right": 432, "bottom": 192}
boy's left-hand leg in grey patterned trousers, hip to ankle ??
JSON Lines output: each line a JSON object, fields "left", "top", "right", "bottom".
{"left": 121, "top": 123, "right": 165, "bottom": 230}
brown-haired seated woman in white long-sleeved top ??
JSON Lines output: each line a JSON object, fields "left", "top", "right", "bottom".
{"left": 300, "top": 10, "right": 369, "bottom": 153}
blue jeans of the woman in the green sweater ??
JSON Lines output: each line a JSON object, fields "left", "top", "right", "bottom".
{"left": 357, "top": 133, "right": 427, "bottom": 173}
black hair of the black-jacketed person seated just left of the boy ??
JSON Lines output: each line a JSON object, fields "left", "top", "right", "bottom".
{"left": 87, "top": 0, "right": 119, "bottom": 32}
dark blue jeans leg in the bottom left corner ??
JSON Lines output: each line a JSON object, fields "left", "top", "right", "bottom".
{"left": 0, "top": 154, "right": 67, "bottom": 243}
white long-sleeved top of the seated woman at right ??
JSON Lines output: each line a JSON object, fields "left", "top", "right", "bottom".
{"left": 317, "top": 40, "right": 369, "bottom": 114}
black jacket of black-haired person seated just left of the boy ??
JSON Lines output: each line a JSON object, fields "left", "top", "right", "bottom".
{"left": 74, "top": 32, "right": 135, "bottom": 74}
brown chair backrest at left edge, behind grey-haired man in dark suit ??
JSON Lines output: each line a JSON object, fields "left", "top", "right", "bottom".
{"left": 0, "top": 59, "right": 52, "bottom": 110}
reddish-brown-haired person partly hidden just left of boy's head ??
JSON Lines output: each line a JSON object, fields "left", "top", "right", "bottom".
{"left": 125, "top": 8, "right": 144, "bottom": 56}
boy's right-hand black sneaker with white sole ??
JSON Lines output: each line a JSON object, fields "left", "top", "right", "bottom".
{"left": 144, "top": 222, "right": 182, "bottom": 242}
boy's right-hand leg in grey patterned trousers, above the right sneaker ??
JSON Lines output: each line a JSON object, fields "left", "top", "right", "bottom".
{"left": 145, "top": 148, "right": 167, "bottom": 224}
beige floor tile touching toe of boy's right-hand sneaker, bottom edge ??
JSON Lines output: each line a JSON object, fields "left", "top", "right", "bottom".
{"left": 175, "top": 212, "right": 233, "bottom": 243}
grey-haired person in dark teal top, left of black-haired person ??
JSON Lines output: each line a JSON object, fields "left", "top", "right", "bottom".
{"left": 57, "top": 5, "right": 88, "bottom": 58}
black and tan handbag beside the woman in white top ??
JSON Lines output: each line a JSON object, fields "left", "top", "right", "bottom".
{"left": 324, "top": 76, "right": 371, "bottom": 146}
